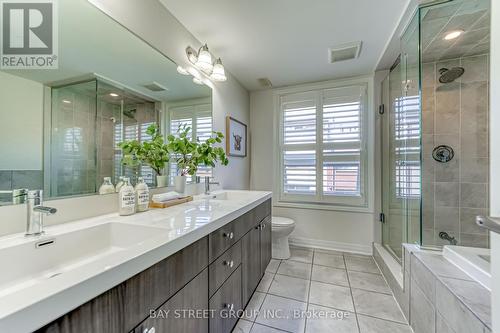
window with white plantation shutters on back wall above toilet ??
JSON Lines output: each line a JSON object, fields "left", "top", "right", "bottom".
{"left": 279, "top": 84, "right": 367, "bottom": 207}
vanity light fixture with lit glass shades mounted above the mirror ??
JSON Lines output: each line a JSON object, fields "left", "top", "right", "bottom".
{"left": 186, "top": 44, "right": 227, "bottom": 82}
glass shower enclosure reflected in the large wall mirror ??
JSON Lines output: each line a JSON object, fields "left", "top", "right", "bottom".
{"left": 45, "top": 79, "right": 160, "bottom": 197}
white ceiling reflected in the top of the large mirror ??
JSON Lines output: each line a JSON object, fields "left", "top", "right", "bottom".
{"left": 2, "top": 0, "right": 211, "bottom": 101}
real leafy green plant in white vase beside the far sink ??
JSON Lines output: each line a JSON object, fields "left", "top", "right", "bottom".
{"left": 167, "top": 126, "right": 229, "bottom": 193}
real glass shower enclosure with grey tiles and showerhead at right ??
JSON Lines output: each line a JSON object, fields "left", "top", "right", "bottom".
{"left": 381, "top": 0, "right": 490, "bottom": 260}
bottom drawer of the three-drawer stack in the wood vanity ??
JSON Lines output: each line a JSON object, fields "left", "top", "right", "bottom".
{"left": 209, "top": 266, "right": 242, "bottom": 333}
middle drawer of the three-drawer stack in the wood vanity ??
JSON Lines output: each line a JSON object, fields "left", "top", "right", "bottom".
{"left": 208, "top": 241, "right": 241, "bottom": 296}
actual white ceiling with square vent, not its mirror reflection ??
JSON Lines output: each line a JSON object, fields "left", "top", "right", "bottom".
{"left": 160, "top": 0, "right": 409, "bottom": 90}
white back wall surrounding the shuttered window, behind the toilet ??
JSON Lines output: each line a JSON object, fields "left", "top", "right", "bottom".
{"left": 250, "top": 81, "right": 378, "bottom": 253}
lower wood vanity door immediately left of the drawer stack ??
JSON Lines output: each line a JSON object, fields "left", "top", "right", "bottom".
{"left": 134, "top": 269, "right": 208, "bottom": 333}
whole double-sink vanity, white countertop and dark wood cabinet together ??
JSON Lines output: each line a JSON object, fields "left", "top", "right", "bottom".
{"left": 0, "top": 191, "right": 271, "bottom": 333}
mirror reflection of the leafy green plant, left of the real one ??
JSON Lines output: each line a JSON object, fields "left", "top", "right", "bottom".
{"left": 118, "top": 124, "right": 170, "bottom": 187}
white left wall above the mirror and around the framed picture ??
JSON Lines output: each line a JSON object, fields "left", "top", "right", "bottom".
{"left": 89, "top": 0, "right": 250, "bottom": 189}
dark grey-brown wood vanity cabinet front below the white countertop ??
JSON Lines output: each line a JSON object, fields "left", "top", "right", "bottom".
{"left": 38, "top": 200, "right": 271, "bottom": 333}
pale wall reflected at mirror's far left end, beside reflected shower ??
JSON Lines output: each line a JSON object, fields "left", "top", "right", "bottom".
{"left": 0, "top": 72, "right": 43, "bottom": 170}
